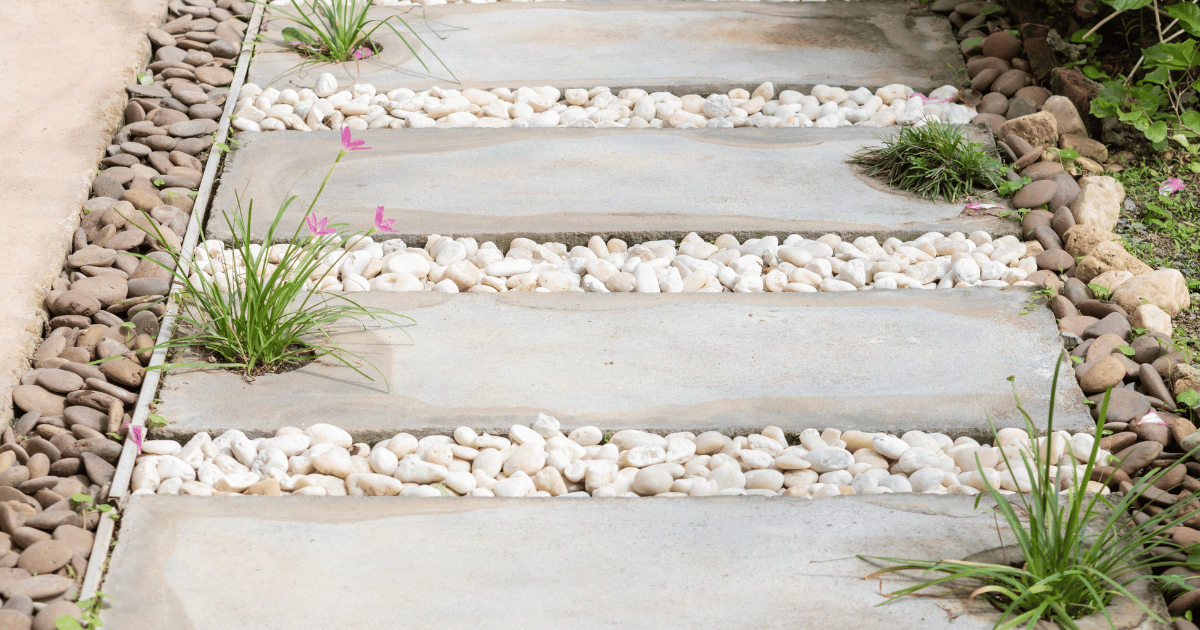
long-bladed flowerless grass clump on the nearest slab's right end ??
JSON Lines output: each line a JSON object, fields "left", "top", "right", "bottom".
{"left": 859, "top": 362, "right": 1200, "bottom": 630}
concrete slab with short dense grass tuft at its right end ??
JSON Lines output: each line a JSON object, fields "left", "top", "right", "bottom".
{"left": 208, "top": 127, "right": 1015, "bottom": 244}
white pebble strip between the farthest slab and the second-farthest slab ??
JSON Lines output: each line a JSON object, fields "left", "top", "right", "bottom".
{"left": 233, "top": 78, "right": 976, "bottom": 131}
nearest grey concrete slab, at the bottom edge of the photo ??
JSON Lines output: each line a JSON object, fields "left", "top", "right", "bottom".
{"left": 101, "top": 496, "right": 1012, "bottom": 630}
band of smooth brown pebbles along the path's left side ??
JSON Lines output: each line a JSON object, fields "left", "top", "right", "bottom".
{"left": 0, "top": 0, "right": 251, "bottom": 629}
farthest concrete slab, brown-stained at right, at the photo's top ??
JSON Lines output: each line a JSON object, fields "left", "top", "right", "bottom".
{"left": 250, "top": 0, "right": 961, "bottom": 95}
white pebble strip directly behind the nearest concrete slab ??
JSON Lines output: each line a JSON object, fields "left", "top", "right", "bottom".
{"left": 132, "top": 414, "right": 1110, "bottom": 499}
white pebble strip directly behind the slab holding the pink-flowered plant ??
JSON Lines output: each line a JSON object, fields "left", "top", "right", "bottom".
{"left": 191, "top": 230, "right": 1042, "bottom": 293}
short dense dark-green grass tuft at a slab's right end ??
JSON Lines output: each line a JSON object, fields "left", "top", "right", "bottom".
{"left": 850, "top": 122, "right": 1004, "bottom": 203}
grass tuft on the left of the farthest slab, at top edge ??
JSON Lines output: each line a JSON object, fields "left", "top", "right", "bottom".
{"left": 256, "top": 0, "right": 458, "bottom": 82}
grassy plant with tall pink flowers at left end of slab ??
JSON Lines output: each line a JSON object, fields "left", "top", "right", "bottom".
{"left": 134, "top": 128, "right": 412, "bottom": 380}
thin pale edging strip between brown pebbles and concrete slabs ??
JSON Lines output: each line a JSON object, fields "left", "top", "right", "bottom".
{"left": 79, "top": 0, "right": 263, "bottom": 600}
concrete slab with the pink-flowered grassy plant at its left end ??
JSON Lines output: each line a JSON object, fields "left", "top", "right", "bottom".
{"left": 157, "top": 289, "right": 1094, "bottom": 440}
